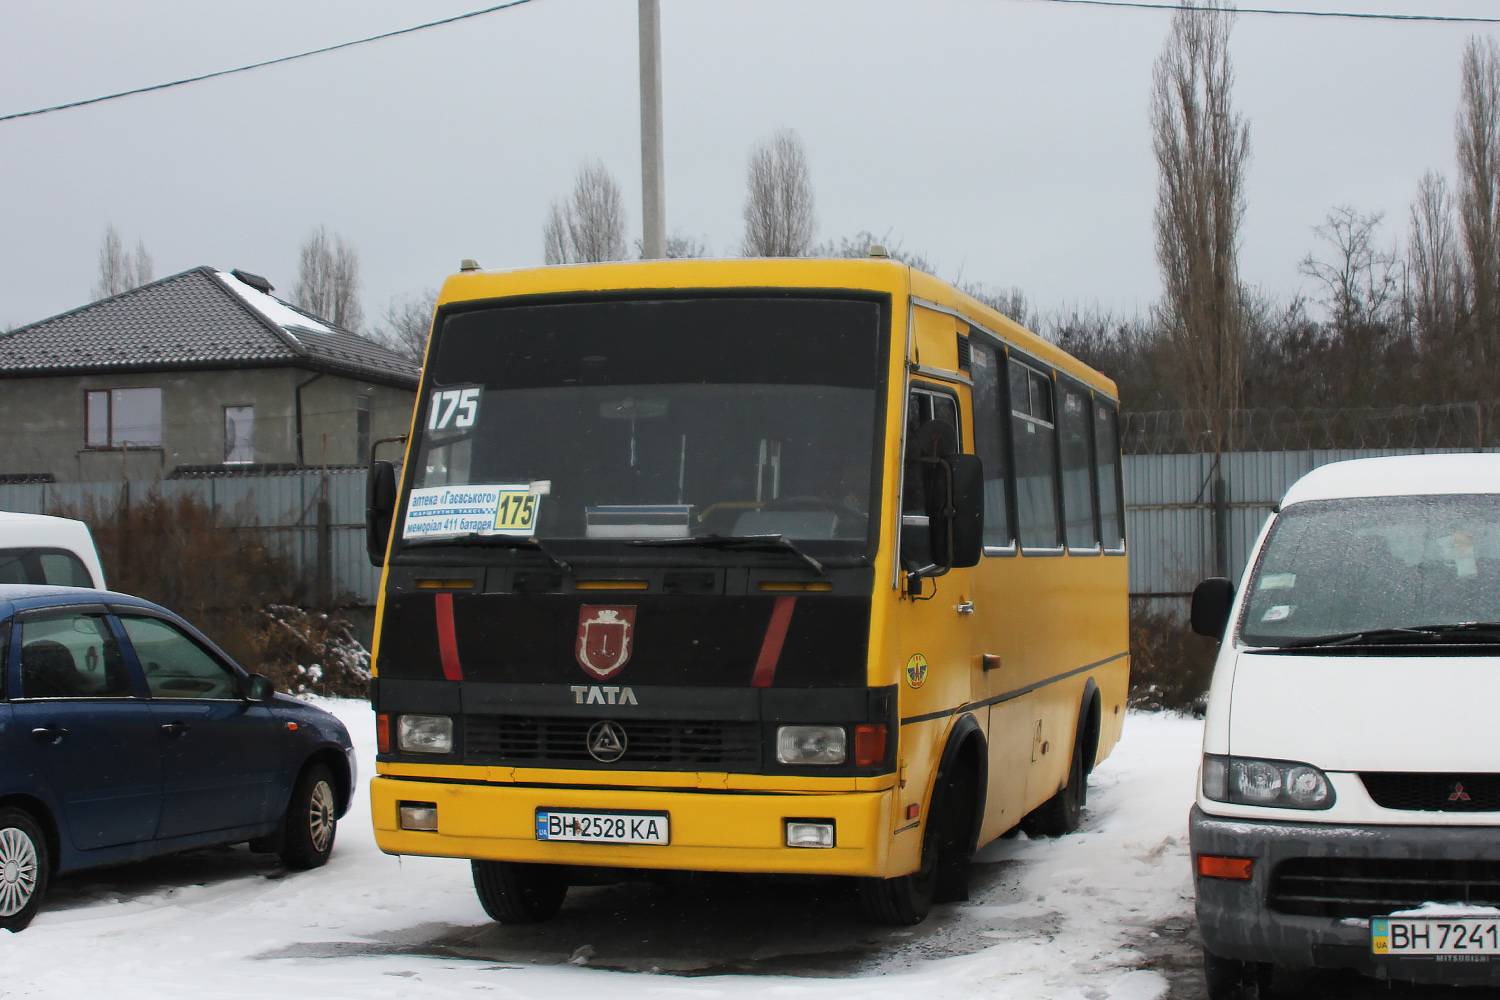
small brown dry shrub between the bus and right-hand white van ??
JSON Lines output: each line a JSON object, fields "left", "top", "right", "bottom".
{"left": 1130, "top": 604, "right": 1218, "bottom": 715}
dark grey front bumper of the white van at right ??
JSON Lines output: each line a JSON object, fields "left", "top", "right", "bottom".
{"left": 1188, "top": 805, "right": 1500, "bottom": 984}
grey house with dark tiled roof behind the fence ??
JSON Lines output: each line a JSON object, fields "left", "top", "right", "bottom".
{"left": 0, "top": 267, "right": 419, "bottom": 483}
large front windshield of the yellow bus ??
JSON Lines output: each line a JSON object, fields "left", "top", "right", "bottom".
{"left": 405, "top": 295, "right": 884, "bottom": 549}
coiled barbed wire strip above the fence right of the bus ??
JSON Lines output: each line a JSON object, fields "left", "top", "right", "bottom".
{"left": 1121, "top": 400, "right": 1500, "bottom": 454}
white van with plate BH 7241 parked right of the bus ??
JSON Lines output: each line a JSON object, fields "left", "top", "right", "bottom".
{"left": 1190, "top": 454, "right": 1500, "bottom": 999}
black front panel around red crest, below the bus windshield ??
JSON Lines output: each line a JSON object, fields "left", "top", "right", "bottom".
{"left": 380, "top": 591, "right": 870, "bottom": 688}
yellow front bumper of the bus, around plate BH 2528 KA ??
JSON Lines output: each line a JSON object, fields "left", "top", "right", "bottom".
{"left": 371, "top": 775, "right": 900, "bottom": 877}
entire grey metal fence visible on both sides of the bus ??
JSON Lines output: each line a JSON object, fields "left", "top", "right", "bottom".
{"left": 0, "top": 447, "right": 1475, "bottom": 613}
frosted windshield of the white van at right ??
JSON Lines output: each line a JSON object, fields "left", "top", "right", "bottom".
{"left": 1241, "top": 495, "right": 1500, "bottom": 646}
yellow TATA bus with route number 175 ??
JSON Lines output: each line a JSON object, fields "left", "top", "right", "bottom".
{"left": 369, "top": 256, "right": 1130, "bottom": 924}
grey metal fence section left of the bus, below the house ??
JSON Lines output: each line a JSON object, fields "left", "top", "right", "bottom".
{"left": 0, "top": 469, "right": 380, "bottom": 604}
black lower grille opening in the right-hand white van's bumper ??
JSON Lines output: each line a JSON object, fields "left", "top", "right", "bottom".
{"left": 1269, "top": 858, "right": 1500, "bottom": 918}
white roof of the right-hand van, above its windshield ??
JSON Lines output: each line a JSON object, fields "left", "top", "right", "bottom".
{"left": 1281, "top": 453, "right": 1500, "bottom": 507}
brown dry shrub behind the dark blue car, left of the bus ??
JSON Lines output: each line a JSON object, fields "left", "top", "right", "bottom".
{"left": 50, "top": 490, "right": 369, "bottom": 697}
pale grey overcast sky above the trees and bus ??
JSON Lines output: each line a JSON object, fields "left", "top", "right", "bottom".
{"left": 0, "top": 0, "right": 1500, "bottom": 335}
